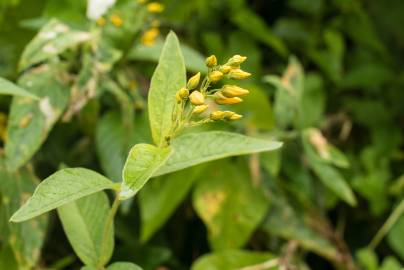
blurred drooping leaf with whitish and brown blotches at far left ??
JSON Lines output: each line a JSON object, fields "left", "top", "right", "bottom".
{"left": 5, "top": 65, "right": 69, "bottom": 171}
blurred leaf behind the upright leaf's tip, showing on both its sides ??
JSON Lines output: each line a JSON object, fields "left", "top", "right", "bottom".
{"left": 128, "top": 39, "right": 207, "bottom": 73}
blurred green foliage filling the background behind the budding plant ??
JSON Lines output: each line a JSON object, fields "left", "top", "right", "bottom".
{"left": 0, "top": 0, "right": 404, "bottom": 270}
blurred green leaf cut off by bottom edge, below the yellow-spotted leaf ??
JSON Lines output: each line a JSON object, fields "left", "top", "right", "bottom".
{"left": 191, "top": 250, "right": 277, "bottom": 270}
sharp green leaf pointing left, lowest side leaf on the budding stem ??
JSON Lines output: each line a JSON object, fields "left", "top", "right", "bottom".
{"left": 10, "top": 168, "right": 113, "bottom": 222}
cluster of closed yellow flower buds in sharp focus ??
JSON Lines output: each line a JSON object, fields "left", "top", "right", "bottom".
{"left": 173, "top": 55, "right": 251, "bottom": 136}
